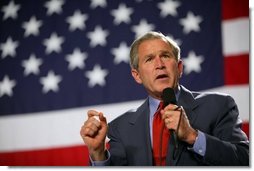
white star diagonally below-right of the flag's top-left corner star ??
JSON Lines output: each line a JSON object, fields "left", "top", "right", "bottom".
{"left": 22, "top": 16, "right": 42, "bottom": 37}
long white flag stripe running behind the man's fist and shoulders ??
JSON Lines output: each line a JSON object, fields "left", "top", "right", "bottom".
{"left": 0, "top": 85, "right": 249, "bottom": 152}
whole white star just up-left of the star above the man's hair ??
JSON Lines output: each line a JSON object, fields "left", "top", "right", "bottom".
{"left": 111, "top": 3, "right": 133, "bottom": 25}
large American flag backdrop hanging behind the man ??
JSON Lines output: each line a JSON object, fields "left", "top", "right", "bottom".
{"left": 0, "top": 0, "right": 249, "bottom": 166}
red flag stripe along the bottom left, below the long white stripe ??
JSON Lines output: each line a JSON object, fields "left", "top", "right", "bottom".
{"left": 0, "top": 145, "right": 89, "bottom": 166}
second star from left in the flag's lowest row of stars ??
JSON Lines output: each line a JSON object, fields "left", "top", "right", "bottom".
{"left": 40, "top": 71, "right": 62, "bottom": 93}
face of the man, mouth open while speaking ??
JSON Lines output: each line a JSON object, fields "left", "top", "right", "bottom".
{"left": 132, "top": 39, "right": 183, "bottom": 99}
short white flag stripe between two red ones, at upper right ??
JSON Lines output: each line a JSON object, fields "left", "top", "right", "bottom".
{"left": 222, "top": 18, "right": 250, "bottom": 57}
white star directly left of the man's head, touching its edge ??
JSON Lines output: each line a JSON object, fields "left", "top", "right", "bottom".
{"left": 111, "top": 42, "right": 130, "bottom": 64}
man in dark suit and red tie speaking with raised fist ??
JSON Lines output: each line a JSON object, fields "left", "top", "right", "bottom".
{"left": 80, "top": 32, "right": 249, "bottom": 166}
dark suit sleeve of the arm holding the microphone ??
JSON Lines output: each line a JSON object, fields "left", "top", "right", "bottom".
{"left": 203, "top": 96, "right": 249, "bottom": 166}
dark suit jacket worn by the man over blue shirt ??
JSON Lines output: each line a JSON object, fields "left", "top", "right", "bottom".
{"left": 108, "top": 86, "right": 249, "bottom": 166}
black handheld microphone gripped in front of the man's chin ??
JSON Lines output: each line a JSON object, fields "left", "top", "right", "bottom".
{"left": 161, "top": 87, "right": 178, "bottom": 148}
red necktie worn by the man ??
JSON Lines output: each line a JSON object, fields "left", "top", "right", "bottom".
{"left": 153, "top": 102, "right": 170, "bottom": 166}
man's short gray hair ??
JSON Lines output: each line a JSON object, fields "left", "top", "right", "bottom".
{"left": 130, "top": 31, "right": 181, "bottom": 69}
